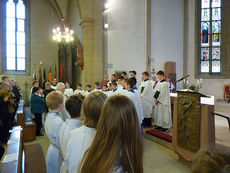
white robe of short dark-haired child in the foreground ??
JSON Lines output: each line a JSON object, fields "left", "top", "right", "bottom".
{"left": 59, "top": 119, "right": 82, "bottom": 173}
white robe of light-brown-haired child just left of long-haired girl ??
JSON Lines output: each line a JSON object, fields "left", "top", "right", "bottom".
{"left": 65, "top": 125, "right": 96, "bottom": 173}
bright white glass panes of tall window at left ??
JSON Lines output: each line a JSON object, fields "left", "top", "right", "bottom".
{"left": 6, "top": 0, "right": 26, "bottom": 71}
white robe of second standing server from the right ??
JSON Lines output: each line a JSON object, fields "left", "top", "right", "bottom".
{"left": 138, "top": 80, "right": 154, "bottom": 118}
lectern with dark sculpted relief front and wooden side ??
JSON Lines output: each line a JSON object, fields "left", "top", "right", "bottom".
{"left": 173, "top": 91, "right": 215, "bottom": 161}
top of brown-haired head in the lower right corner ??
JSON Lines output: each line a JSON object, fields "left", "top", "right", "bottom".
{"left": 191, "top": 147, "right": 230, "bottom": 173}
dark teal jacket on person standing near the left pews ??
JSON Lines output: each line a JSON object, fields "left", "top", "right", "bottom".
{"left": 30, "top": 94, "right": 45, "bottom": 114}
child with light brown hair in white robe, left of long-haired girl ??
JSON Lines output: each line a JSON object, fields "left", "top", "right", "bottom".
{"left": 65, "top": 91, "right": 107, "bottom": 173}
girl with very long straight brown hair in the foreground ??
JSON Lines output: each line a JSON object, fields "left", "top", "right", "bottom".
{"left": 78, "top": 95, "right": 143, "bottom": 173}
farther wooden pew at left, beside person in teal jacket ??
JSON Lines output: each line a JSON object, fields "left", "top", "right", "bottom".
{"left": 17, "top": 100, "right": 36, "bottom": 142}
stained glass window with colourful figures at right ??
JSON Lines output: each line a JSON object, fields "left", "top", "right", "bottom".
{"left": 200, "top": 0, "right": 221, "bottom": 73}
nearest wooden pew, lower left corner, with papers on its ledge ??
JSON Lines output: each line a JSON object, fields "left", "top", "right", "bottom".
{"left": 0, "top": 126, "right": 46, "bottom": 173}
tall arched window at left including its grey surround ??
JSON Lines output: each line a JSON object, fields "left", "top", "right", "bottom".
{"left": 1, "top": 0, "right": 29, "bottom": 74}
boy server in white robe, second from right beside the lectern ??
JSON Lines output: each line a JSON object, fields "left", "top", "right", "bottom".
{"left": 138, "top": 71, "right": 153, "bottom": 127}
